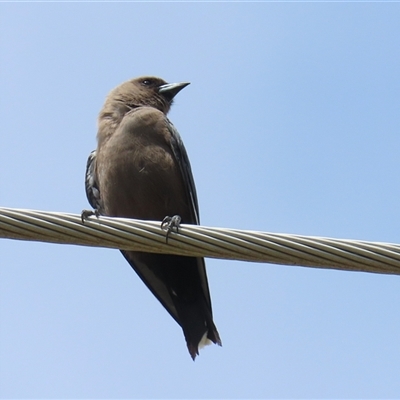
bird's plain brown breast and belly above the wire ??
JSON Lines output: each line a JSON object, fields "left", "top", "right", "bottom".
{"left": 97, "top": 107, "right": 190, "bottom": 220}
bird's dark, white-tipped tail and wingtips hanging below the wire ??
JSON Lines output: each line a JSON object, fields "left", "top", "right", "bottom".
{"left": 121, "top": 250, "right": 221, "bottom": 360}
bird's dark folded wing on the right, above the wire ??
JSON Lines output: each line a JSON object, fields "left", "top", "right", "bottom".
{"left": 167, "top": 119, "right": 200, "bottom": 225}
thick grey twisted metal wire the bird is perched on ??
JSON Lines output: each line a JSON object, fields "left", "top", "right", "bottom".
{"left": 0, "top": 208, "right": 400, "bottom": 275}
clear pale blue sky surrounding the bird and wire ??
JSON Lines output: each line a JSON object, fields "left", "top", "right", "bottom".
{"left": 0, "top": 2, "right": 400, "bottom": 398}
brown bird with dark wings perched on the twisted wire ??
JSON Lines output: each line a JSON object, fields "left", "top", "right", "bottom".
{"left": 82, "top": 76, "right": 222, "bottom": 360}
